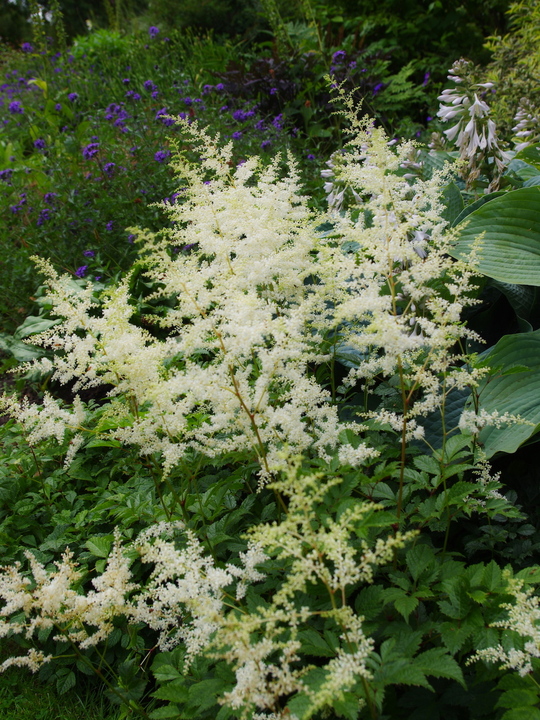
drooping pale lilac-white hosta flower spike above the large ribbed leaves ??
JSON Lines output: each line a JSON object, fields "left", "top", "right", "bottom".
{"left": 437, "top": 59, "right": 509, "bottom": 189}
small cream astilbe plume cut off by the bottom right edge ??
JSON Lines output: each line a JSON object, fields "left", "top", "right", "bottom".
{"left": 468, "top": 571, "right": 540, "bottom": 676}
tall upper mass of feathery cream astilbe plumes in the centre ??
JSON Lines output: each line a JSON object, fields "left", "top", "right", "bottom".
{"left": 4, "top": 108, "right": 488, "bottom": 477}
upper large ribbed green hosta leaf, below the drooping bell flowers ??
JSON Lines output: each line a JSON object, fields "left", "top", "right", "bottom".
{"left": 452, "top": 186, "right": 540, "bottom": 285}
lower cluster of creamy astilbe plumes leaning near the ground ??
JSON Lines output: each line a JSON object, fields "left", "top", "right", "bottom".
{"left": 0, "top": 462, "right": 415, "bottom": 718}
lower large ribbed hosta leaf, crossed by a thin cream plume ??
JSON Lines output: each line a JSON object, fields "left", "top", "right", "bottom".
{"left": 479, "top": 330, "right": 540, "bottom": 457}
